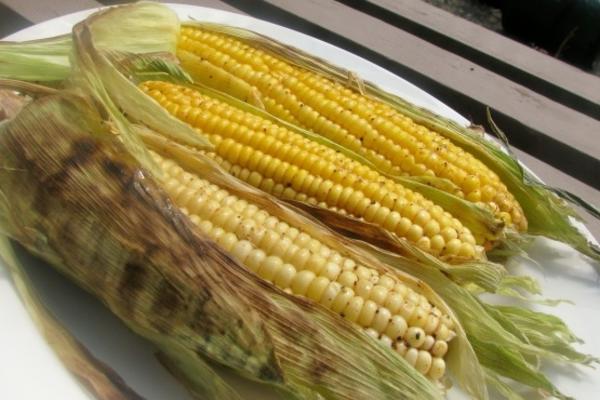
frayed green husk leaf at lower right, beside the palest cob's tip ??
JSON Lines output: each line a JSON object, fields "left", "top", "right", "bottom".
{"left": 363, "top": 244, "right": 596, "bottom": 398}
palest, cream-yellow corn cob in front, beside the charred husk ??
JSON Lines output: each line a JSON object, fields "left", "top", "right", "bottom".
{"left": 152, "top": 149, "right": 455, "bottom": 380}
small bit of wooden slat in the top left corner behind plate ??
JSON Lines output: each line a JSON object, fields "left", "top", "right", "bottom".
{"left": 2, "top": 0, "right": 101, "bottom": 24}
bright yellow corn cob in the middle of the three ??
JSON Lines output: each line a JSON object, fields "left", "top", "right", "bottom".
{"left": 141, "top": 82, "right": 485, "bottom": 260}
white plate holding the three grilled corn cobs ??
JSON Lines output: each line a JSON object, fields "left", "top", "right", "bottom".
{"left": 0, "top": 4, "right": 600, "bottom": 400}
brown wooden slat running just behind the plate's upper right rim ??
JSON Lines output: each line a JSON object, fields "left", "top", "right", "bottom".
{"left": 236, "top": 0, "right": 600, "bottom": 188}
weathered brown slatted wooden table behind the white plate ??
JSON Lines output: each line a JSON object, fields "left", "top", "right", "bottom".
{"left": 0, "top": 0, "right": 600, "bottom": 238}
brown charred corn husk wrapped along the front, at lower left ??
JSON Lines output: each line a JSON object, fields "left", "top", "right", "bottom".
{"left": 0, "top": 88, "right": 450, "bottom": 399}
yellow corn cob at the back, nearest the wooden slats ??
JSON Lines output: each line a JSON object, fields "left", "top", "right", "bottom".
{"left": 177, "top": 27, "right": 527, "bottom": 230}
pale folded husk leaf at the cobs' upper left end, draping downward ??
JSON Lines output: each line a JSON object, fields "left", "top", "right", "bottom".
{"left": 71, "top": 3, "right": 212, "bottom": 177}
